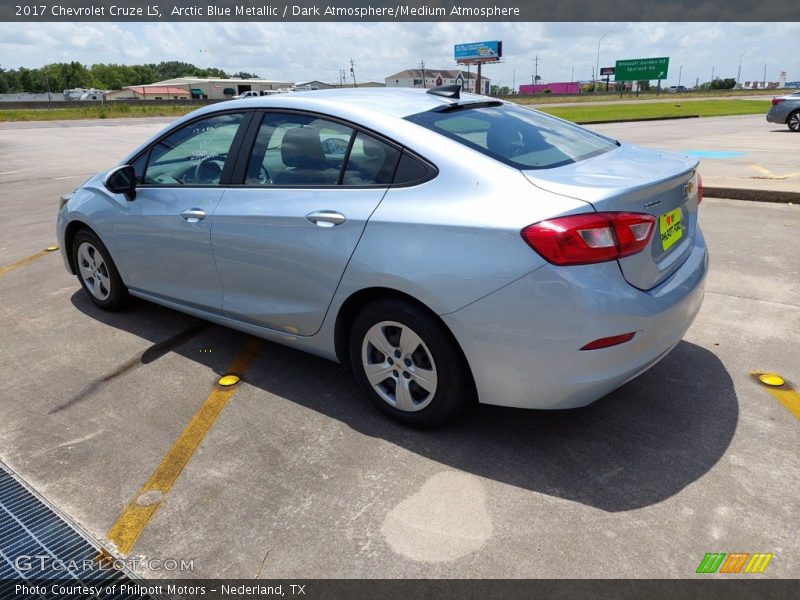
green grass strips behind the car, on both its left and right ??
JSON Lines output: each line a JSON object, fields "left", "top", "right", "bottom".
{"left": 0, "top": 98, "right": 769, "bottom": 123}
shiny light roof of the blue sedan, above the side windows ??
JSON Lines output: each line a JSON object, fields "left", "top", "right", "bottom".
{"left": 222, "top": 87, "right": 491, "bottom": 118}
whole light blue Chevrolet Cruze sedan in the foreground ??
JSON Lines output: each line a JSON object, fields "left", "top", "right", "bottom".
{"left": 58, "top": 86, "right": 708, "bottom": 427}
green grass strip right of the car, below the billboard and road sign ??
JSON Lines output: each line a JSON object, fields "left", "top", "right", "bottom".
{"left": 537, "top": 100, "right": 770, "bottom": 123}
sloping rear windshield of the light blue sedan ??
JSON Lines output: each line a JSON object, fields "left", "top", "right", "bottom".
{"left": 406, "top": 103, "right": 618, "bottom": 169}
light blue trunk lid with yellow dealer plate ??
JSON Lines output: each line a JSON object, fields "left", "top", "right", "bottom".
{"left": 523, "top": 144, "right": 698, "bottom": 290}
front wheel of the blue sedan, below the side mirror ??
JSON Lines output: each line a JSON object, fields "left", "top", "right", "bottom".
{"left": 72, "top": 229, "right": 130, "bottom": 311}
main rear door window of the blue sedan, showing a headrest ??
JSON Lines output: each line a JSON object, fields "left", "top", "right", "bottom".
{"left": 245, "top": 113, "right": 353, "bottom": 187}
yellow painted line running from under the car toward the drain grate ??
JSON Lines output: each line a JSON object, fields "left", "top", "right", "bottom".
{"left": 107, "top": 338, "right": 262, "bottom": 554}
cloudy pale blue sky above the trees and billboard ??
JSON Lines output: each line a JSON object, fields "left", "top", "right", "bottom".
{"left": 0, "top": 23, "right": 800, "bottom": 87}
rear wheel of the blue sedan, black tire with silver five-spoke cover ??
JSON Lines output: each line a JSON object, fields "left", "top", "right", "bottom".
{"left": 349, "top": 299, "right": 476, "bottom": 428}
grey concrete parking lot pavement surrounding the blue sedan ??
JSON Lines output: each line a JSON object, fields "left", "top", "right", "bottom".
{"left": 0, "top": 115, "right": 800, "bottom": 578}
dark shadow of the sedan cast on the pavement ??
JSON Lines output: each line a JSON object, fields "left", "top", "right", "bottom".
{"left": 72, "top": 292, "right": 739, "bottom": 512}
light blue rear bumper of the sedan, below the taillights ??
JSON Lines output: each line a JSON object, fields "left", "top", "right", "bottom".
{"left": 442, "top": 228, "right": 708, "bottom": 409}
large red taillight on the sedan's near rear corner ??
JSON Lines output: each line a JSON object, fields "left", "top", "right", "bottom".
{"left": 522, "top": 212, "right": 656, "bottom": 266}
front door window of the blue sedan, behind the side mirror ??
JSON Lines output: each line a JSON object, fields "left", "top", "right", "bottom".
{"left": 143, "top": 113, "right": 243, "bottom": 186}
